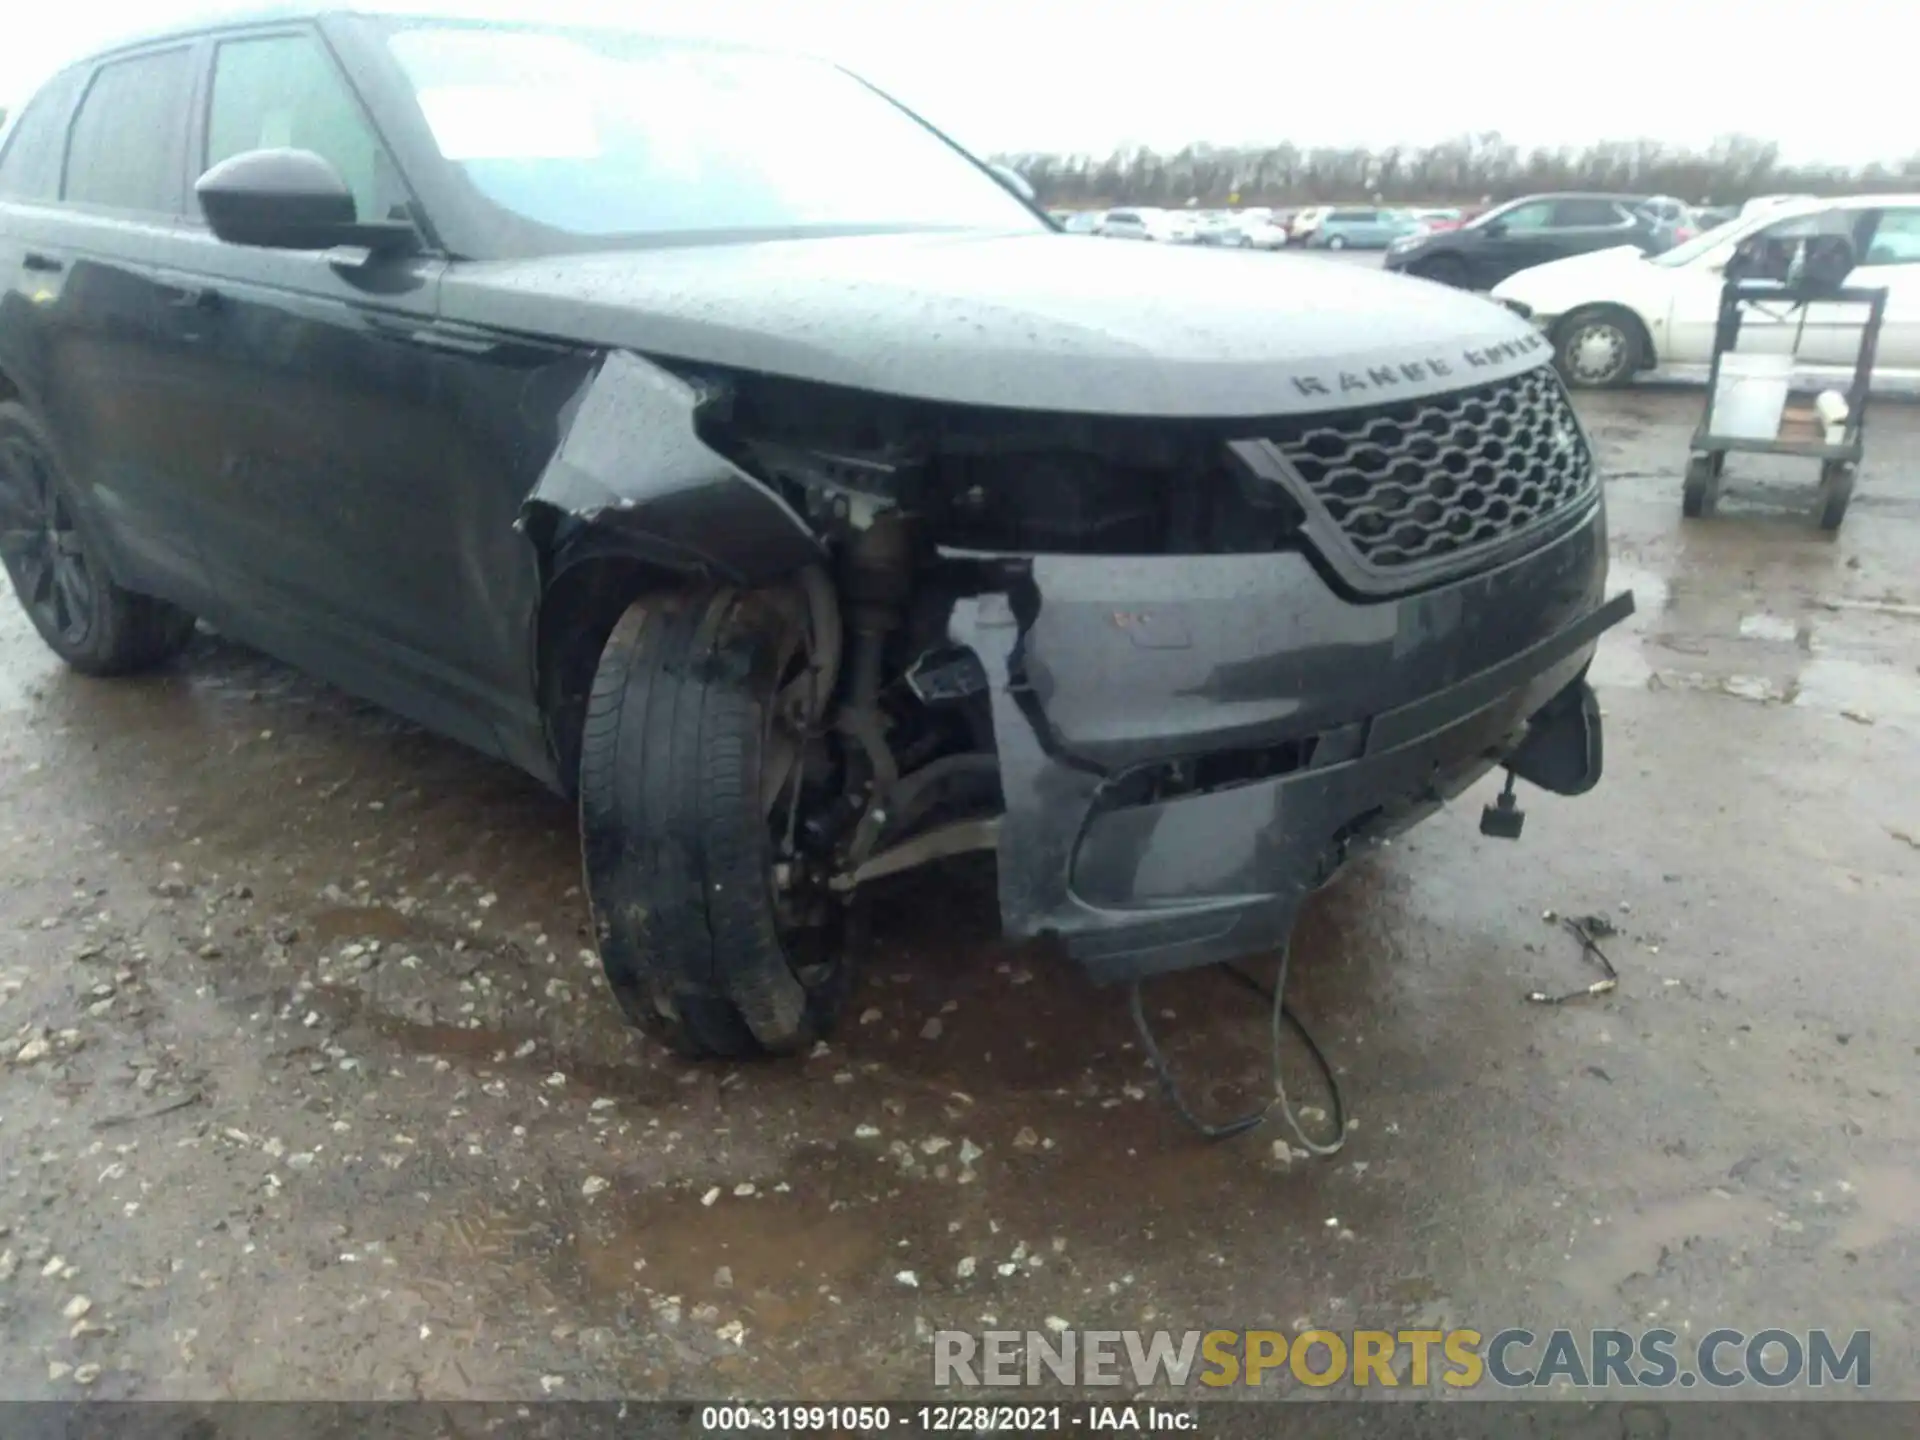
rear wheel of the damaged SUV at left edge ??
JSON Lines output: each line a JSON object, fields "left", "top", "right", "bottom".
{"left": 0, "top": 401, "right": 194, "bottom": 676}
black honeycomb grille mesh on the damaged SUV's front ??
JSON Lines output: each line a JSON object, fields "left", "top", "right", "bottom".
{"left": 1273, "top": 367, "right": 1597, "bottom": 572}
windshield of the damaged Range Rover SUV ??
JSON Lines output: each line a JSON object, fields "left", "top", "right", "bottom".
{"left": 386, "top": 21, "right": 1046, "bottom": 236}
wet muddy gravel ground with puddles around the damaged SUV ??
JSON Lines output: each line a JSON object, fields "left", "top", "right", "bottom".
{"left": 0, "top": 390, "right": 1920, "bottom": 1400}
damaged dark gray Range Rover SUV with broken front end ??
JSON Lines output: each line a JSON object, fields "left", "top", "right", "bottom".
{"left": 0, "top": 12, "right": 1632, "bottom": 1056}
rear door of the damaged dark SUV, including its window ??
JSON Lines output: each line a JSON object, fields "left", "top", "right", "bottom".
{"left": 6, "top": 42, "right": 219, "bottom": 609}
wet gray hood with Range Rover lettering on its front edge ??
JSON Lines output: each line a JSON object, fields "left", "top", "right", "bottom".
{"left": 442, "top": 234, "right": 1546, "bottom": 417}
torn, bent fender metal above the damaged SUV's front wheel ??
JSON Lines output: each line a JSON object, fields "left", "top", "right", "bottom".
{"left": 520, "top": 349, "right": 824, "bottom": 586}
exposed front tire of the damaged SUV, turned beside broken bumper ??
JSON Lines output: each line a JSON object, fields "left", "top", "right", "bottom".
{"left": 580, "top": 589, "right": 852, "bottom": 1058}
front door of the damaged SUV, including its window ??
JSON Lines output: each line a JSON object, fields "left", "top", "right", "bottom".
{"left": 157, "top": 27, "right": 551, "bottom": 751}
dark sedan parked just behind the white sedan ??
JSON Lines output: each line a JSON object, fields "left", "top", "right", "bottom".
{"left": 1386, "top": 194, "right": 1663, "bottom": 290}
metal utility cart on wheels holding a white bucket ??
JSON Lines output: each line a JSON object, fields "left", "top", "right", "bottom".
{"left": 1680, "top": 278, "right": 1887, "bottom": 530}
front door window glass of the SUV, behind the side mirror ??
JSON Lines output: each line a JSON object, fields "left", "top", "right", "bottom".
{"left": 205, "top": 35, "right": 405, "bottom": 221}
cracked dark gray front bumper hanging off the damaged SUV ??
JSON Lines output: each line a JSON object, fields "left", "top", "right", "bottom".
{"left": 952, "top": 503, "right": 1634, "bottom": 981}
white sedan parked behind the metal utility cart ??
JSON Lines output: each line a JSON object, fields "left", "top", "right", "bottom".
{"left": 1494, "top": 196, "right": 1920, "bottom": 386}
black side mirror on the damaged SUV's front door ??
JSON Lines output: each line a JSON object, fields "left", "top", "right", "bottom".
{"left": 194, "top": 150, "right": 417, "bottom": 250}
